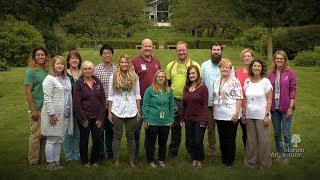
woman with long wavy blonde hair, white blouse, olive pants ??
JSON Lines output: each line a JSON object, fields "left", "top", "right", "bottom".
{"left": 108, "top": 55, "right": 141, "bottom": 167}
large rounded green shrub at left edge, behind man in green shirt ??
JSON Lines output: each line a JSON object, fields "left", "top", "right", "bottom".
{"left": 0, "top": 16, "right": 44, "bottom": 66}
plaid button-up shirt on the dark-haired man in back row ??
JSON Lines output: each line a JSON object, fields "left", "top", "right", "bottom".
{"left": 94, "top": 63, "right": 116, "bottom": 99}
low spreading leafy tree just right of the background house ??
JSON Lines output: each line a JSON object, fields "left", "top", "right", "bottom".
{"left": 172, "top": 0, "right": 244, "bottom": 36}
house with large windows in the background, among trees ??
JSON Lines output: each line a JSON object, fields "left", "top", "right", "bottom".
{"left": 144, "top": 0, "right": 171, "bottom": 26}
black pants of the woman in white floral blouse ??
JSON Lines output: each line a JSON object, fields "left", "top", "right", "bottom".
{"left": 216, "top": 120, "right": 237, "bottom": 166}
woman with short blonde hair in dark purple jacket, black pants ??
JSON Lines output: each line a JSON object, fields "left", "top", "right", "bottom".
{"left": 73, "top": 61, "right": 106, "bottom": 167}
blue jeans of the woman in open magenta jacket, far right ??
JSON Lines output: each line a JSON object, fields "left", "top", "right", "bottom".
{"left": 271, "top": 110, "right": 291, "bottom": 157}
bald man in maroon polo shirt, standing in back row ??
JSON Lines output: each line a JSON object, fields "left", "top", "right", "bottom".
{"left": 132, "top": 39, "right": 161, "bottom": 161}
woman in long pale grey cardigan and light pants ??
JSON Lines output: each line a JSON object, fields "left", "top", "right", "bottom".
{"left": 41, "top": 56, "right": 73, "bottom": 170}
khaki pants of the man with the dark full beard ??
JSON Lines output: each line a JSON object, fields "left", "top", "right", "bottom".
{"left": 207, "top": 106, "right": 216, "bottom": 150}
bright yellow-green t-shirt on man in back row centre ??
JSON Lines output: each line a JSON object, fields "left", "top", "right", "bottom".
{"left": 166, "top": 59, "right": 200, "bottom": 100}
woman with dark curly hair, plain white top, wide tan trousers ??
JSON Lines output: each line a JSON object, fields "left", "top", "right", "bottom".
{"left": 243, "top": 60, "right": 272, "bottom": 167}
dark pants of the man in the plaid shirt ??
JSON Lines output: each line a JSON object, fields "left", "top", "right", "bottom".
{"left": 99, "top": 109, "right": 114, "bottom": 159}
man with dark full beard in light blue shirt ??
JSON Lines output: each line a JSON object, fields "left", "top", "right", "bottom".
{"left": 201, "top": 43, "right": 234, "bottom": 155}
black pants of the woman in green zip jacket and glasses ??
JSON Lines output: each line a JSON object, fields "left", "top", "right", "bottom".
{"left": 145, "top": 125, "right": 170, "bottom": 163}
